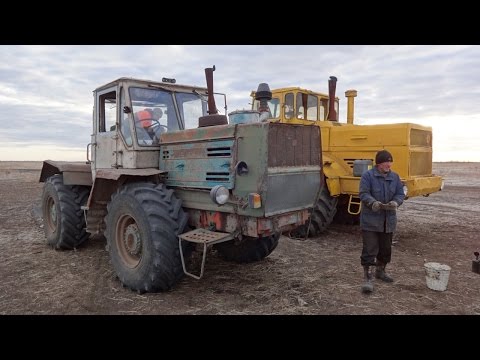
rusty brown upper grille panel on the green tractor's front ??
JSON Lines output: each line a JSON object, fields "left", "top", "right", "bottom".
{"left": 268, "top": 123, "right": 320, "bottom": 167}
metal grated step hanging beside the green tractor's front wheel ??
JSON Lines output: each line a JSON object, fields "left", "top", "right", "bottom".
{"left": 178, "top": 228, "right": 233, "bottom": 280}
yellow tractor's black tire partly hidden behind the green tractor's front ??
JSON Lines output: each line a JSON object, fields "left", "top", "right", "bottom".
{"left": 291, "top": 186, "right": 338, "bottom": 238}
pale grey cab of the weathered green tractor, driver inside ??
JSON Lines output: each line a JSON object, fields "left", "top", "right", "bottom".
{"left": 92, "top": 78, "right": 226, "bottom": 172}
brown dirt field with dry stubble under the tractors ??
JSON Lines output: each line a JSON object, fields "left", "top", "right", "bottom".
{"left": 0, "top": 162, "right": 480, "bottom": 314}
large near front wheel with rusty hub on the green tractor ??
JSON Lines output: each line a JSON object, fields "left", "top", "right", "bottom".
{"left": 105, "top": 182, "right": 188, "bottom": 293}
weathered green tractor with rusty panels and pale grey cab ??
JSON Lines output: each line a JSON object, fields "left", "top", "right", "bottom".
{"left": 40, "top": 67, "right": 322, "bottom": 293}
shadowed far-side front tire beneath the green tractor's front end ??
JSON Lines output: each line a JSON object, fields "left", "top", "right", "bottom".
{"left": 215, "top": 233, "right": 280, "bottom": 263}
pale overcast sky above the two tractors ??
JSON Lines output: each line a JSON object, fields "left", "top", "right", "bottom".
{"left": 0, "top": 45, "right": 480, "bottom": 161}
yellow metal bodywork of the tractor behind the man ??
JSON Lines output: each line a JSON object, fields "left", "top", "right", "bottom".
{"left": 251, "top": 87, "right": 443, "bottom": 207}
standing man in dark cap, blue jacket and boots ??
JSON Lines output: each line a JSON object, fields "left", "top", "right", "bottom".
{"left": 360, "top": 150, "right": 405, "bottom": 293}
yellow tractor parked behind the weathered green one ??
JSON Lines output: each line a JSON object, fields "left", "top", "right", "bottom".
{"left": 249, "top": 76, "right": 443, "bottom": 236}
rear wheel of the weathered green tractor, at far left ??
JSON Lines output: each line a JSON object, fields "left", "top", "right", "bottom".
{"left": 42, "top": 175, "right": 90, "bottom": 250}
